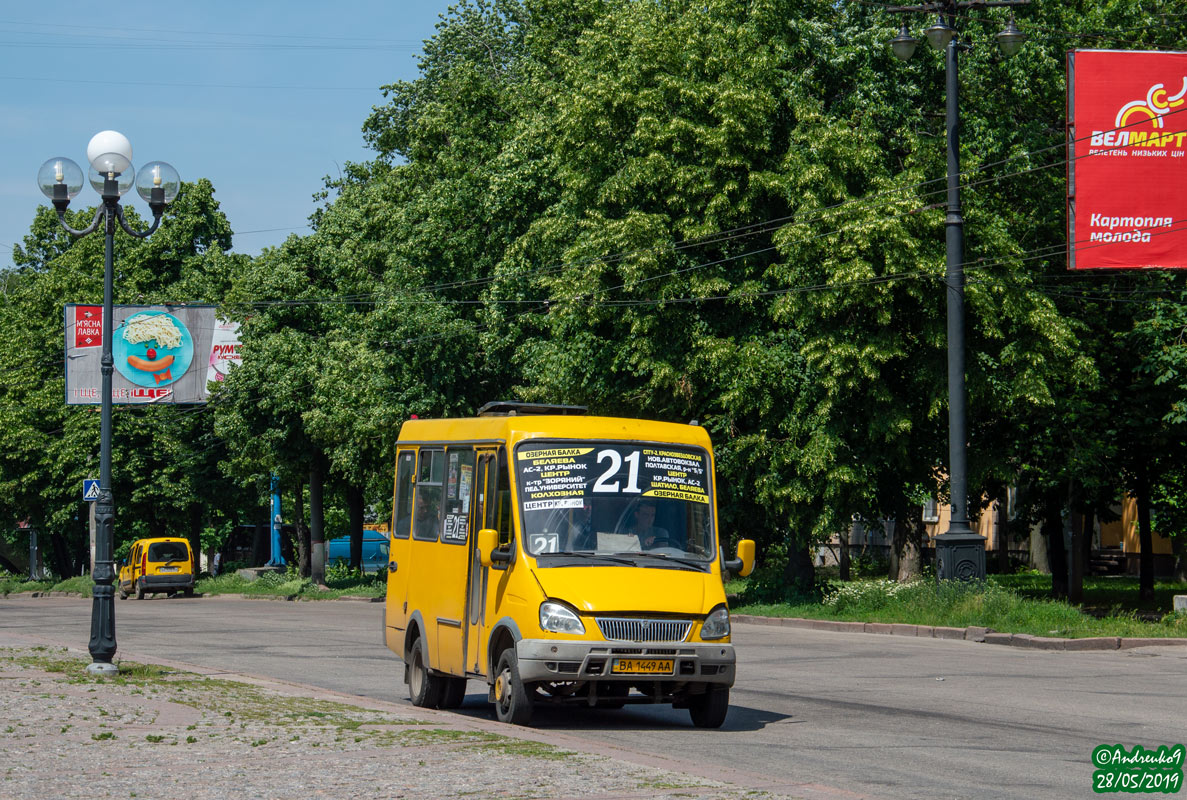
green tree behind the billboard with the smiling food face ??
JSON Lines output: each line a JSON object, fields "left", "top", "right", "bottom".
{"left": 0, "top": 180, "right": 245, "bottom": 574}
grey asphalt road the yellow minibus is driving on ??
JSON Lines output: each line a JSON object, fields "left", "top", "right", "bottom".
{"left": 0, "top": 597, "right": 1187, "bottom": 800}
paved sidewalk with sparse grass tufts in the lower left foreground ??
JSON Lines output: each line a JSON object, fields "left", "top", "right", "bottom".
{"left": 0, "top": 647, "right": 787, "bottom": 800}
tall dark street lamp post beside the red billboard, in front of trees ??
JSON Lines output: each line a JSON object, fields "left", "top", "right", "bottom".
{"left": 888, "top": 0, "right": 1030, "bottom": 580}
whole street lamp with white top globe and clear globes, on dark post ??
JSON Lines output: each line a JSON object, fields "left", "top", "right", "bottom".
{"left": 37, "top": 131, "right": 180, "bottom": 674}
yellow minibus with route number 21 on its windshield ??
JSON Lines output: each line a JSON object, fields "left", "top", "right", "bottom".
{"left": 383, "top": 402, "right": 754, "bottom": 728}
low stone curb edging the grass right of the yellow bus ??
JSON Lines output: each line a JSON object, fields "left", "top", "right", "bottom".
{"left": 730, "top": 614, "right": 1187, "bottom": 652}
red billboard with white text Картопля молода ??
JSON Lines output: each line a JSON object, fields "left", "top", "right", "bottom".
{"left": 1067, "top": 50, "right": 1187, "bottom": 269}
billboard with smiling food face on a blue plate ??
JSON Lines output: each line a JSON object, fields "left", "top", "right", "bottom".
{"left": 65, "top": 303, "right": 240, "bottom": 406}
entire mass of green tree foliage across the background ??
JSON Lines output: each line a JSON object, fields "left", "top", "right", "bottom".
{"left": 0, "top": 0, "right": 1187, "bottom": 590}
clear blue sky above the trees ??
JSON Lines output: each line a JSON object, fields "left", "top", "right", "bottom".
{"left": 0, "top": 0, "right": 455, "bottom": 269}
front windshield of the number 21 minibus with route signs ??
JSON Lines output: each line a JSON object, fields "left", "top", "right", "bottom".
{"left": 515, "top": 439, "right": 717, "bottom": 566}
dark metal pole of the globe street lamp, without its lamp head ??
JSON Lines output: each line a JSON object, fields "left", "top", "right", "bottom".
{"left": 87, "top": 177, "right": 120, "bottom": 673}
